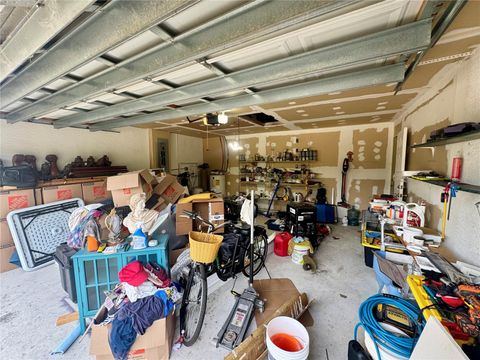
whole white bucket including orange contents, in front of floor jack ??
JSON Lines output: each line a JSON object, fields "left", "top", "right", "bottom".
{"left": 265, "top": 316, "right": 310, "bottom": 360}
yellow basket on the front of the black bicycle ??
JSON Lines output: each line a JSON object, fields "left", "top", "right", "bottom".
{"left": 188, "top": 231, "right": 223, "bottom": 264}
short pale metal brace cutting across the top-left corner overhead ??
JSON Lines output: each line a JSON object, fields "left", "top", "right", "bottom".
{"left": 0, "top": 0, "right": 95, "bottom": 81}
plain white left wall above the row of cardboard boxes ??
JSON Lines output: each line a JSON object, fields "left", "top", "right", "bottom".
{"left": 0, "top": 120, "right": 150, "bottom": 170}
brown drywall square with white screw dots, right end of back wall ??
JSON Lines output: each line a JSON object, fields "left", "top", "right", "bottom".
{"left": 352, "top": 128, "right": 388, "bottom": 169}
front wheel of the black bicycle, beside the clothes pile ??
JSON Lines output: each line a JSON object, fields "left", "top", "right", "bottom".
{"left": 180, "top": 263, "right": 207, "bottom": 346}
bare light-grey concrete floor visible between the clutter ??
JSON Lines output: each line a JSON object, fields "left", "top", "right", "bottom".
{"left": 0, "top": 226, "right": 377, "bottom": 360}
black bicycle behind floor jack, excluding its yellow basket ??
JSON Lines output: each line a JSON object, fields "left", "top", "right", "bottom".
{"left": 180, "top": 211, "right": 268, "bottom": 346}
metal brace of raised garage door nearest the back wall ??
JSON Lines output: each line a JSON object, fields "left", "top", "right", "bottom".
{"left": 90, "top": 64, "right": 405, "bottom": 130}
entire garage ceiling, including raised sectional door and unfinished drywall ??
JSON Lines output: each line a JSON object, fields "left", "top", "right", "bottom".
{"left": 0, "top": 0, "right": 480, "bottom": 136}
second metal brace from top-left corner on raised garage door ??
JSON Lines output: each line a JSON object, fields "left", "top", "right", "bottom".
{"left": 0, "top": 0, "right": 199, "bottom": 107}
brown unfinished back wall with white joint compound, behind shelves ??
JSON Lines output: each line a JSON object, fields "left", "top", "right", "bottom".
{"left": 226, "top": 123, "right": 393, "bottom": 209}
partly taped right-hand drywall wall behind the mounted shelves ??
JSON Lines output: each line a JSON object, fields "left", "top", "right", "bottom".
{"left": 394, "top": 49, "right": 480, "bottom": 266}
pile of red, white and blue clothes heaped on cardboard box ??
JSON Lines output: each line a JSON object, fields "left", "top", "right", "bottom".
{"left": 96, "top": 261, "right": 181, "bottom": 360}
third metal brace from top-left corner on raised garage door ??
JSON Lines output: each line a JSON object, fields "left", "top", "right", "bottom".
{"left": 3, "top": 0, "right": 370, "bottom": 122}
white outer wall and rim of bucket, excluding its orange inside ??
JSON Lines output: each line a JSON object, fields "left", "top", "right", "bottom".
{"left": 266, "top": 316, "right": 310, "bottom": 360}
